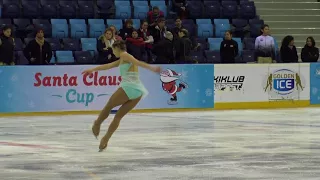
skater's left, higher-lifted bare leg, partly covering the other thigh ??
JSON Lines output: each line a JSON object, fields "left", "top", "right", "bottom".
{"left": 92, "top": 88, "right": 129, "bottom": 137}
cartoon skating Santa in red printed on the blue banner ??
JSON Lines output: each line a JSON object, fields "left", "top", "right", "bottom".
{"left": 160, "top": 69, "right": 188, "bottom": 105}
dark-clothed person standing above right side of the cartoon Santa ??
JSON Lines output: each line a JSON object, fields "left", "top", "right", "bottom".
{"left": 175, "top": 29, "right": 195, "bottom": 63}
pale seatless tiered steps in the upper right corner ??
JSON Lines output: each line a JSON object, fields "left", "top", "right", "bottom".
{"left": 254, "top": 0, "right": 320, "bottom": 59}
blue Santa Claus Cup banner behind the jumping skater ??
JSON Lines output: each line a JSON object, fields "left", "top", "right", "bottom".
{"left": 0, "top": 65, "right": 214, "bottom": 112}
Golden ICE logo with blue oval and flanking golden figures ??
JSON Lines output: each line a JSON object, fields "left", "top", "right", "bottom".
{"left": 263, "top": 69, "right": 305, "bottom": 100}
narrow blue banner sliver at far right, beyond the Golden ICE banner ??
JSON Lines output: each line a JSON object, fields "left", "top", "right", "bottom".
{"left": 310, "top": 63, "right": 320, "bottom": 104}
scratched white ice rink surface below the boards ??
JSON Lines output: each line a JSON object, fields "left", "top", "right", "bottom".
{"left": 0, "top": 108, "right": 320, "bottom": 180}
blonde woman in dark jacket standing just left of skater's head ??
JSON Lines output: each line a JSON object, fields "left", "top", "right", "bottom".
{"left": 97, "top": 28, "right": 116, "bottom": 64}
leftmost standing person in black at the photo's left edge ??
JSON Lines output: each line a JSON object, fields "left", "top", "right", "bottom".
{"left": 0, "top": 26, "right": 15, "bottom": 66}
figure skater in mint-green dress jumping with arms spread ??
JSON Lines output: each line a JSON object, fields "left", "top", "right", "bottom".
{"left": 82, "top": 41, "right": 161, "bottom": 152}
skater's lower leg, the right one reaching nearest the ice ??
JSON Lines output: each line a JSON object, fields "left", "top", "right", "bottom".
{"left": 99, "top": 97, "right": 141, "bottom": 150}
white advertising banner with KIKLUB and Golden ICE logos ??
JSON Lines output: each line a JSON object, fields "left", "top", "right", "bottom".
{"left": 214, "top": 64, "right": 310, "bottom": 103}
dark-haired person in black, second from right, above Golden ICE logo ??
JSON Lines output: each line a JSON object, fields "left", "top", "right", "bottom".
{"left": 280, "top": 36, "right": 298, "bottom": 63}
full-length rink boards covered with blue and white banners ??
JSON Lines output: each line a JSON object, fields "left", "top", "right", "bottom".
{"left": 0, "top": 63, "right": 320, "bottom": 115}
